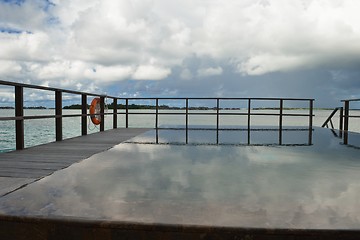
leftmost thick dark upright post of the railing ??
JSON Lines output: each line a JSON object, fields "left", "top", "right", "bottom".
{"left": 15, "top": 86, "right": 24, "bottom": 150}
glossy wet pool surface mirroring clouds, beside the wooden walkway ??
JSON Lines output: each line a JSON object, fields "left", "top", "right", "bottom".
{"left": 0, "top": 128, "right": 360, "bottom": 229}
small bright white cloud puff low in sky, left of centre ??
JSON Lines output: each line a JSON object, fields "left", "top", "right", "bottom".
{"left": 132, "top": 65, "right": 171, "bottom": 80}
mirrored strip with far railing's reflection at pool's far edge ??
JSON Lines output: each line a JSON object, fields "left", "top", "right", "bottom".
{"left": 127, "top": 126, "right": 313, "bottom": 146}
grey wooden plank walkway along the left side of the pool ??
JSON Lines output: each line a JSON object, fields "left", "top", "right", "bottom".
{"left": 0, "top": 128, "right": 149, "bottom": 196}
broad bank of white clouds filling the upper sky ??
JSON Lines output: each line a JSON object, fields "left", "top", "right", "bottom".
{"left": 0, "top": 0, "right": 360, "bottom": 89}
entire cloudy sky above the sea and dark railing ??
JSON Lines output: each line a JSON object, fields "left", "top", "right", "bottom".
{"left": 0, "top": 0, "right": 360, "bottom": 107}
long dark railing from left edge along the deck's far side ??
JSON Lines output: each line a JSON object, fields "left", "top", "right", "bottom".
{"left": 0, "top": 80, "right": 314, "bottom": 150}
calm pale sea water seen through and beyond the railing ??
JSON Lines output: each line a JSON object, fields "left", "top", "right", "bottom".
{"left": 0, "top": 109, "right": 360, "bottom": 152}
